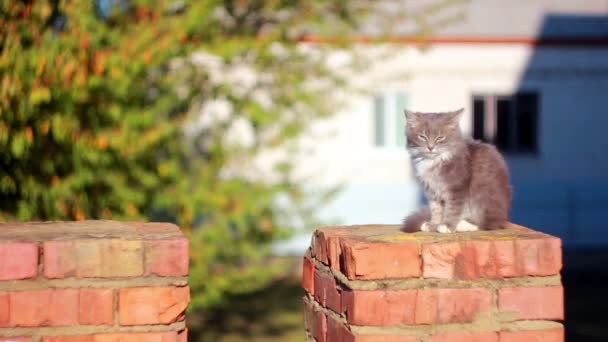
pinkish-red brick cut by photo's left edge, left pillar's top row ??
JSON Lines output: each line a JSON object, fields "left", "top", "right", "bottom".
{"left": 0, "top": 242, "right": 38, "bottom": 280}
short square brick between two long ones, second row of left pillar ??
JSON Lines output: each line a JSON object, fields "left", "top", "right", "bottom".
{"left": 78, "top": 289, "right": 114, "bottom": 325}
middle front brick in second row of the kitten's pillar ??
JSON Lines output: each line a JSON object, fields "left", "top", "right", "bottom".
{"left": 415, "top": 288, "right": 492, "bottom": 324}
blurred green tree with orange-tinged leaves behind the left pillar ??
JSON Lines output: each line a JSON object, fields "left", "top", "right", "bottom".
{"left": 0, "top": 0, "right": 460, "bottom": 316}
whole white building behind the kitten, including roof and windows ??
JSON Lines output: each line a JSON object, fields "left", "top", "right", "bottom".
{"left": 276, "top": 0, "right": 608, "bottom": 254}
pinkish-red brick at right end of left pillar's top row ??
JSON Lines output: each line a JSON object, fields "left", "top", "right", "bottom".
{"left": 144, "top": 237, "right": 189, "bottom": 277}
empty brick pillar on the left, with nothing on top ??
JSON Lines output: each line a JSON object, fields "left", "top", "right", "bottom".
{"left": 0, "top": 221, "right": 190, "bottom": 342}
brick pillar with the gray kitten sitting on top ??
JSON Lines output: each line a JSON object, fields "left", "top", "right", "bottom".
{"left": 303, "top": 225, "right": 564, "bottom": 342}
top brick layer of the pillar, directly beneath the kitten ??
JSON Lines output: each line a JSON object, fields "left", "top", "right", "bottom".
{"left": 311, "top": 224, "right": 562, "bottom": 280}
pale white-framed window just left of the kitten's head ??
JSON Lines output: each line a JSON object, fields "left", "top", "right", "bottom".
{"left": 373, "top": 92, "right": 407, "bottom": 148}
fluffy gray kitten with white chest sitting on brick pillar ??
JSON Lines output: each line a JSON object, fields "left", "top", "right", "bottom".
{"left": 404, "top": 109, "right": 512, "bottom": 233}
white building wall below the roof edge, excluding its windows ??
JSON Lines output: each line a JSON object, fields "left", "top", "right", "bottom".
{"left": 282, "top": 44, "right": 608, "bottom": 251}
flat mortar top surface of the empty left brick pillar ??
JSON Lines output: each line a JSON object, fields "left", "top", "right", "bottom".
{"left": 0, "top": 220, "right": 183, "bottom": 242}
